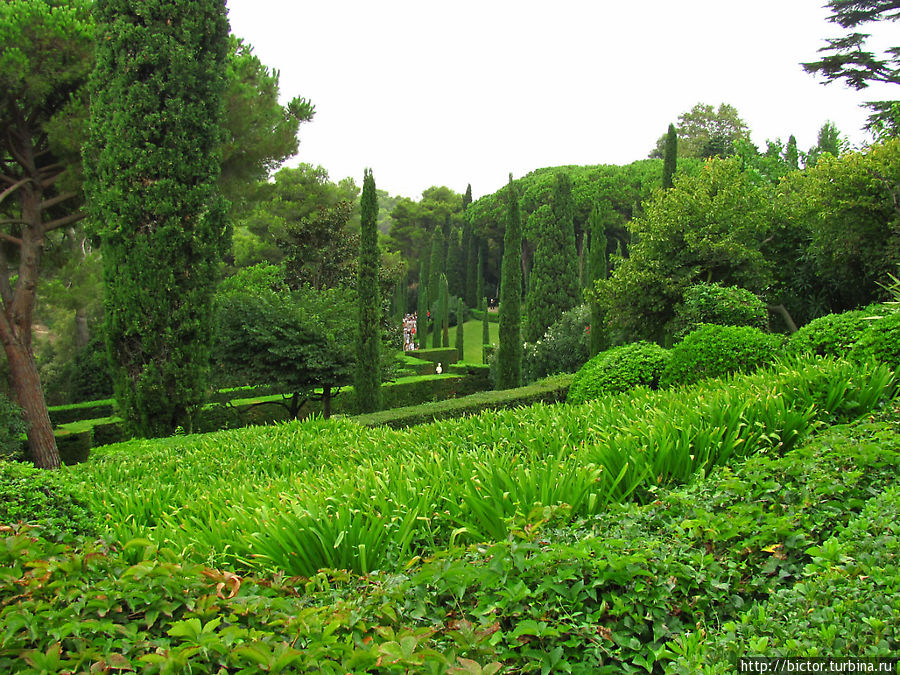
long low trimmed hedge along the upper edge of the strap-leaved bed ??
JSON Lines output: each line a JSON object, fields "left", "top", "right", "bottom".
{"left": 350, "top": 375, "right": 574, "bottom": 429}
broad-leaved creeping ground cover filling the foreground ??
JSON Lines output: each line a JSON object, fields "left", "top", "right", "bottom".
{"left": 0, "top": 394, "right": 900, "bottom": 673}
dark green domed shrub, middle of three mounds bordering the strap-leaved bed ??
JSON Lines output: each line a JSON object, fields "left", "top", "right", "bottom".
{"left": 660, "top": 324, "right": 784, "bottom": 387}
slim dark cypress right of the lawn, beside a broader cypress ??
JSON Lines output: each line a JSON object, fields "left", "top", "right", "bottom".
{"left": 496, "top": 174, "right": 522, "bottom": 389}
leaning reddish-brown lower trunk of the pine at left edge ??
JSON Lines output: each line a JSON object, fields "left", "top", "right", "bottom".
{"left": 4, "top": 341, "right": 60, "bottom": 469}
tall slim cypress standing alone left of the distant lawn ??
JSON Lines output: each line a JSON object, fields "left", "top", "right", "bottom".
{"left": 354, "top": 169, "right": 381, "bottom": 413}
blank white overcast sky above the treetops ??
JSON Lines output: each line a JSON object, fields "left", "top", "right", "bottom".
{"left": 228, "top": 0, "right": 900, "bottom": 199}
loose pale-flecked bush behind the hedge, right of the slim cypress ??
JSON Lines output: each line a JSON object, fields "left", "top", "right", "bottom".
{"left": 522, "top": 305, "right": 591, "bottom": 382}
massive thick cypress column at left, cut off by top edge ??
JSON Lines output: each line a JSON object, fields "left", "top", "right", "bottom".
{"left": 84, "top": 0, "right": 230, "bottom": 436}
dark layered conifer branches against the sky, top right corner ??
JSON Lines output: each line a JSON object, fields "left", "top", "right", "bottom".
{"left": 803, "top": 0, "right": 900, "bottom": 136}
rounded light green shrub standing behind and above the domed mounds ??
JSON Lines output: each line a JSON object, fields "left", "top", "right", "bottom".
{"left": 671, "top": 284, "right": 768, "bottom": 340}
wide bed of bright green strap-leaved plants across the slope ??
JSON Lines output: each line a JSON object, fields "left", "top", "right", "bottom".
{"left": 44, "top": 360, "right": 895, "bottom": 575}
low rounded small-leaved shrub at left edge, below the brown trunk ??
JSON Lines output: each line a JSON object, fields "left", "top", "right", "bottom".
{"left": 0, "top": 460, "right": 97, "bottom": 538}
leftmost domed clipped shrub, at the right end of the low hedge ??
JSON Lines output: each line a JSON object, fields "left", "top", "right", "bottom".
{"left": 567, "top": 342, "right": 669, "bottom": 403}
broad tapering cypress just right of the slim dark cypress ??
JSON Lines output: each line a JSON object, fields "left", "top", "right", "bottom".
{"left": 524, "top": 172, "right": 581, "bottom": 342}
